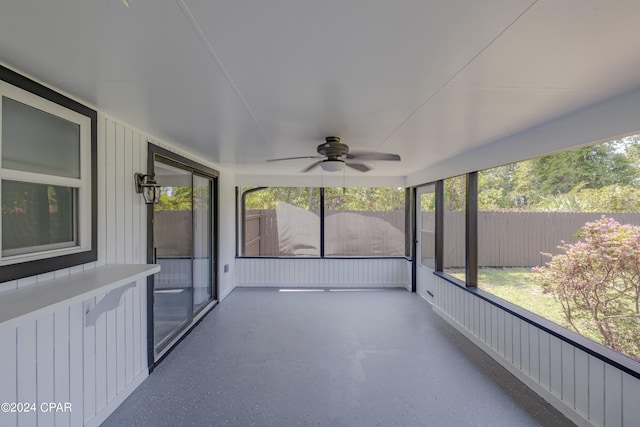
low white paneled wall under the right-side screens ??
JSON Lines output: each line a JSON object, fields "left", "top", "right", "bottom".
{"left": 433, "top": 277, "right": 640, "bottom": 427}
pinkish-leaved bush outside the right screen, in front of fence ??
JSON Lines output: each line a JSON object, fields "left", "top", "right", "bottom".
{"left": 533, "top": 216, "right": 640, "bottom": 360}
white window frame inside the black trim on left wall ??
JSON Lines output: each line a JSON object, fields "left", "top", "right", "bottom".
{"left": 0, "top": 81, "right": 92, "bottom": 266}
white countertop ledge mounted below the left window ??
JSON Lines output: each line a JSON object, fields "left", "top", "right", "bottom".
{"left": 0, "top": 264, "right": 160, "bottom": 328}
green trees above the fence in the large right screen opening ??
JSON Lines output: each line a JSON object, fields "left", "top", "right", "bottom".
{"left": 478, "top": 134, "right": 640, "bottom": 212}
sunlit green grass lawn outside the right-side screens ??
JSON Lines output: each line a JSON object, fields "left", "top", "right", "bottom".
{"left": 447, "top": 267, "right": 568, "bottom": 327}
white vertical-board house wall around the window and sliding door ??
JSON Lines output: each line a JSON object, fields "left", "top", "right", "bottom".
{"left": 0, "top": 78, "right": 235, "bottom": 427}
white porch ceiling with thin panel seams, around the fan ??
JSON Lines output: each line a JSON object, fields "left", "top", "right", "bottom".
{"left": 0, "top": 0, "right": 640, "bottom": 176}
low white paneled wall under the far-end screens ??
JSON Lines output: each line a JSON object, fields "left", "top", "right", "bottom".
{"left": 236, "top": 258, "right": 411, "bottom": 289}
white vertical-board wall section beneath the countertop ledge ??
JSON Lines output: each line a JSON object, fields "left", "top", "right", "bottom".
{"left": 0, "top": 279, "right": 147, "bottom": 427}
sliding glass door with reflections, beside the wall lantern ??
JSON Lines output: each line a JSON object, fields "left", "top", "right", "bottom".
{"left": 153, "top": 158, "right": 215, "bottom": 360}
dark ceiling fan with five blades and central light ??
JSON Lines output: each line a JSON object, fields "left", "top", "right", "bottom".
{"left": 267, "top": 136, "right": 400, "bottom": 172}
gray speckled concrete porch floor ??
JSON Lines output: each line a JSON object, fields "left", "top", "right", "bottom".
{"left": 103, "top": 289, "right": 573, "bottom": 427}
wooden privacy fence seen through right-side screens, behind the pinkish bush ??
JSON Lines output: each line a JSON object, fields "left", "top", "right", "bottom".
{"left": 443, "top": 211, "right": 640, "bottom": 268}
